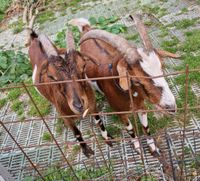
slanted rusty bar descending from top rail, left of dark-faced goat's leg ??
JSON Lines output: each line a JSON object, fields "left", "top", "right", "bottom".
{"left": 23, "top": 83, "right": 79, "bottom": 180}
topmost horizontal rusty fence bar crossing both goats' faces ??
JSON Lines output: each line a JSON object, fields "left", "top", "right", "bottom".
{"left": 0, "top": 69, "right": 200, "bottom": 91}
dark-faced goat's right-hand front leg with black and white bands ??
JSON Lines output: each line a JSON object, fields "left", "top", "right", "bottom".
{"left": 94, "top": 115, "right": 113, "bottom": 147}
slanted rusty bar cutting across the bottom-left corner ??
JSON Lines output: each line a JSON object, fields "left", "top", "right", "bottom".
{"left": 0, "top": 121, "right": 45, "bottom": 181}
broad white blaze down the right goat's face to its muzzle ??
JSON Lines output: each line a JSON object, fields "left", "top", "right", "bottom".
{"left": 137, "top": 48, "right": 176, "bottom": 106}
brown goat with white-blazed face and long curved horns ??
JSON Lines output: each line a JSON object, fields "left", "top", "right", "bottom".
{"left": 69, "top": 16, "right": 178, "bottom": 154}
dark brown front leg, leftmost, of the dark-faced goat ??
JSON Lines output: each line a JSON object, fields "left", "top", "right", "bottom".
{"left": 64, "top": 119, "right": 94, "bottom": 158}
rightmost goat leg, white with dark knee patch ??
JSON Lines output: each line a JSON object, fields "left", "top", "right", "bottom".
{"left": 138, "top": 113, "right": 160, "bottom": 156}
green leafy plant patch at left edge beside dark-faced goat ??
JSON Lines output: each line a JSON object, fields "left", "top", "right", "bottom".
{"left": 0, "top": 50, "right": 32, "bottom": 87}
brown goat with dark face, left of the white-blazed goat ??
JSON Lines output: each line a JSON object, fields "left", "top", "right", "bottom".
{"left": 29, "top": 30, "right": 106, "bottom": 157}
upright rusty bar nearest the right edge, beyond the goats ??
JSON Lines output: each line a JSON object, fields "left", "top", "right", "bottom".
{"left": 181, "top": 65, "right": 189, "bottom": 179}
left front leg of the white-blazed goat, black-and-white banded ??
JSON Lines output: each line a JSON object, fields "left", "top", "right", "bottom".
{"left": 120, "top": 115, "right": 141, "bottom": 154}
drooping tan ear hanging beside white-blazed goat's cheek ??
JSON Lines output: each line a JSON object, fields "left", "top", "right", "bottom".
{"left": 117, "top": 60, "right": 128, "bottom": 91}
